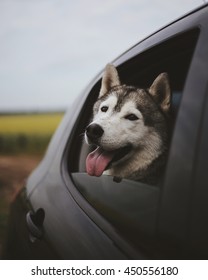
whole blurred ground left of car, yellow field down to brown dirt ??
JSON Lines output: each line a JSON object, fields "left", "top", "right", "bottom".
{"left": 0, "top": 112, "right": 64, "bottom": 258}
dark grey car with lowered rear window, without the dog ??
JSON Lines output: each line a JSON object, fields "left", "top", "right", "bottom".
{"left": 3, "top": 4, "right": 208, "bottom": 260}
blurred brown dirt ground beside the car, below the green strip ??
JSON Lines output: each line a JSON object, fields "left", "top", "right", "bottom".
{"left": 0, "top": 155, "right": 41, "bottom": 257}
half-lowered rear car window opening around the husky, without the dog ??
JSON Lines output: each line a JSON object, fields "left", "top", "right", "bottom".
{"left": 67, "top": 28, "right": 199, "bottom": 254}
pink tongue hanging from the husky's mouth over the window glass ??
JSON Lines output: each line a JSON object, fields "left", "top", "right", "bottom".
{"left": 86, "top": 147, "right": 114, "bottom": 177}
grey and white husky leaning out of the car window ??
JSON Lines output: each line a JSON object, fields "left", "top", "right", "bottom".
{"left": 85, "top": 64, "right": 171, "bottom": 183}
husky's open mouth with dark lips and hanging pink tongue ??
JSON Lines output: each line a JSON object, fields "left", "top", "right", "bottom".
{"left": 86, "top": 145, "right": 132, "bottom": 177}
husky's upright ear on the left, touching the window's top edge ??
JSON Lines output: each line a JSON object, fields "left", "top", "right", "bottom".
{"left": 99, "top": 64, "right": 120, "bottom": 97}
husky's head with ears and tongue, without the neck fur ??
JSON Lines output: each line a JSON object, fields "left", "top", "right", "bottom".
{"left": 85, "top": 64, "right": 171, "bottom": 176}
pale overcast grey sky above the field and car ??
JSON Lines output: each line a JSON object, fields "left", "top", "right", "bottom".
{"left": 0, "top": 0, "right": 206, "bottom": 112}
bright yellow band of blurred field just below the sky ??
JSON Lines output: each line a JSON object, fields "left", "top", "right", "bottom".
{"left": 0, "top": 113, "right": 63, "bottom": 135}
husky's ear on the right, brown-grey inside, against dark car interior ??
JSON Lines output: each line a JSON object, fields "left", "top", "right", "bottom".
{"left": 149, "top": 73, "right": 171, "bottom": 113}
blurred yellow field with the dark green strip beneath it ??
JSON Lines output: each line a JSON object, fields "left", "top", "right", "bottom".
{"left": 0, "top": 112, "right": 63, "bottom": 154}
